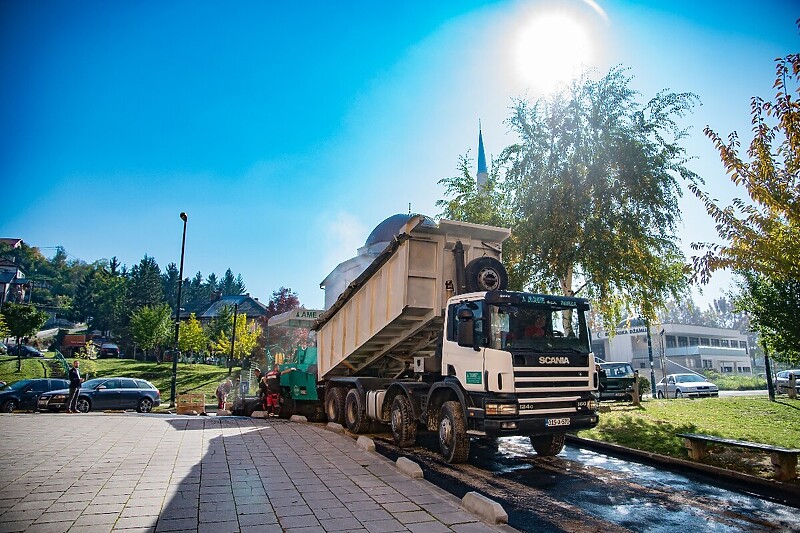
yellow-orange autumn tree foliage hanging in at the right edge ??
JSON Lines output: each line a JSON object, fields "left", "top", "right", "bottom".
{"left": 690, "top": 46, "right": 800, "bottom": 285}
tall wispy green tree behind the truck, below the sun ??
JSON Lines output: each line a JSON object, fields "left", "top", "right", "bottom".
{"left": 440, "top": 67, "right": 699, "bottom": 329}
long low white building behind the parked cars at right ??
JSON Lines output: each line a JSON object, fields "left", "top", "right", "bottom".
{"left": 592, "top": 320, "right": 753, "bottom": 379}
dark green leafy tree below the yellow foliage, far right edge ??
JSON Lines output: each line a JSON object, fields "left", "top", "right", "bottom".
{"left": 734, "top": 272, "right": 800, "bottom": 366}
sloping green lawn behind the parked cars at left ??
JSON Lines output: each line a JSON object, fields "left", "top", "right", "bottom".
{"left": 0, "top": 354, "right": 240, "bottom": 402}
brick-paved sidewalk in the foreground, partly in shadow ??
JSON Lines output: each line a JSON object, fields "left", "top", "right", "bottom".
{"left": 0, "top": 413, "right": 510, "bottom": 533}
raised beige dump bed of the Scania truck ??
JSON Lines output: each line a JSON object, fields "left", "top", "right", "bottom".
{"left": 315, "top": 216, "right": 511, "bottom": 378}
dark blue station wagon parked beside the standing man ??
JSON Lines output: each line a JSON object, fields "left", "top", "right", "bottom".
{"left": 38, "top": 378, "right": 161, "bottom": 413}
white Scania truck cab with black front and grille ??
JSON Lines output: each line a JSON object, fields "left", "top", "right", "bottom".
{"left": 442, "top": 291, "right": 598, "bottom": 436}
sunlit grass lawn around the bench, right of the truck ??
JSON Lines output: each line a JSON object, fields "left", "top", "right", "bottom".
{"left": 577, "top": 396, "right": 800, "bottom": 477}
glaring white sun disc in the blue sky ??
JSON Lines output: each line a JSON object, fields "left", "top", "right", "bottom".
{"left": 514, "top": 12, "right": 593, "bottom": 93}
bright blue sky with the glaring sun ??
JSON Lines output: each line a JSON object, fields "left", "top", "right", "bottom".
{"left": 0, "top": 0, "right": 800, "bottom": 308}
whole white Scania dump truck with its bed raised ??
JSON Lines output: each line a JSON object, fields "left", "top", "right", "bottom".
{"left": 282, "top": 215, "right": 598, "bottom": 463}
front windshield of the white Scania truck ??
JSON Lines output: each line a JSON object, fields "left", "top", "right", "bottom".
{"left": 488, "top": 303, "right": 590, "bottom": 353}
